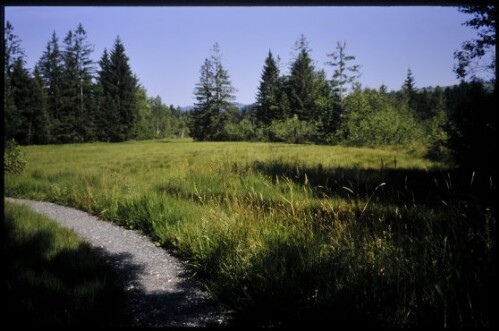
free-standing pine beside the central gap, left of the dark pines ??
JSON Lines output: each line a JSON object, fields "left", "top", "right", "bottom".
{"left": 190, "top": 43, "right": 236, "bottom": 140}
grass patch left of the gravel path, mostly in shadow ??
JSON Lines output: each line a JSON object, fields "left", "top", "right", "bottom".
{"left": 2, "top": 202, "right": 130, "bottom": 328}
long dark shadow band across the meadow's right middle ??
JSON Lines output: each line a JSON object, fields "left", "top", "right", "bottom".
{"left": 252, "top": 161, "right": 496, "bottom": 206}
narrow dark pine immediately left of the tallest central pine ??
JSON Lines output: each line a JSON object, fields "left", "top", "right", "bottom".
{"left": 256, "top": 50, "right": 283, "bottom": 125}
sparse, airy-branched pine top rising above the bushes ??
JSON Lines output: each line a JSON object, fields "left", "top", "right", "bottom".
{"left": 326, "top": 42, "right": 360, "bottom": 103}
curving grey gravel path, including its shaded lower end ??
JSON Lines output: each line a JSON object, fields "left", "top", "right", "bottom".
{"left": 6, "top": 198, "right": 228, "bottom": 327}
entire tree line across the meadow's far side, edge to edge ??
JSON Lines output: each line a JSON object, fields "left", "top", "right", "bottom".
{"left": 4, "top": 6, "right": 497, "bottom": 174}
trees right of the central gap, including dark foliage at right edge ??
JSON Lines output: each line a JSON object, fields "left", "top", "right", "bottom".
{"left": 189, "top": 6, "right": 497, "bottom": 171}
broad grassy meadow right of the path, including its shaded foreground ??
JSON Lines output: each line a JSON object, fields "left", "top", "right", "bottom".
{"left": 4, "top": 140, "right": 496, "bottom": 327}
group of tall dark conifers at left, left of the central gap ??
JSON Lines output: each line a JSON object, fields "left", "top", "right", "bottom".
{"left": 4, "top": 21, "right": 188, "bottom": 144}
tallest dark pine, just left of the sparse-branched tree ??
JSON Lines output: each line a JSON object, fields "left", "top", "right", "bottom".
{"left": 288, "top": 35, "right": 314, "bottom": 121}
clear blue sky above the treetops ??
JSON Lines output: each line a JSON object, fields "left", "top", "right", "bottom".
{"left": 5, "top": 6, "right": 476, "bottom": 106}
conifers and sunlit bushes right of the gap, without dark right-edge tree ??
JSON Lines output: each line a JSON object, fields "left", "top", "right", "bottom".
{"left": 190, "top": 36, "right": 485, "bottom": 149}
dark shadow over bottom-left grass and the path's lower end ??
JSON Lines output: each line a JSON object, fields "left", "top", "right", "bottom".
{"left": 3, "top": 211, "right": 226, "bottom": 327}
